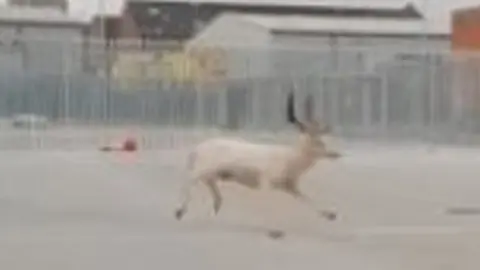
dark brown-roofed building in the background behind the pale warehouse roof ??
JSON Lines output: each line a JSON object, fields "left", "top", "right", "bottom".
{"left": 123, "top": 0, "right": 421, "bottom": 41}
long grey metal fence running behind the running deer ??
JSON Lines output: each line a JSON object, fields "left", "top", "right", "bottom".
{"left": 0, "top": 37, "right": 480, "bottom": 149}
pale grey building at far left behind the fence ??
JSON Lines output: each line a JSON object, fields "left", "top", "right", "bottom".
{"left": 0, "top": 6, "right": 89, "bottom": 74}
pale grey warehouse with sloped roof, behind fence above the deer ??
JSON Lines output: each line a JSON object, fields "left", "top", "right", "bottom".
{"left": 187, "top": 14, "right": 450, "bottom": 77}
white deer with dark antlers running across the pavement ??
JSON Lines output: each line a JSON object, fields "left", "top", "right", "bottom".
{"left": 175, "top": 90, "right": 340, "bottom": 220}
